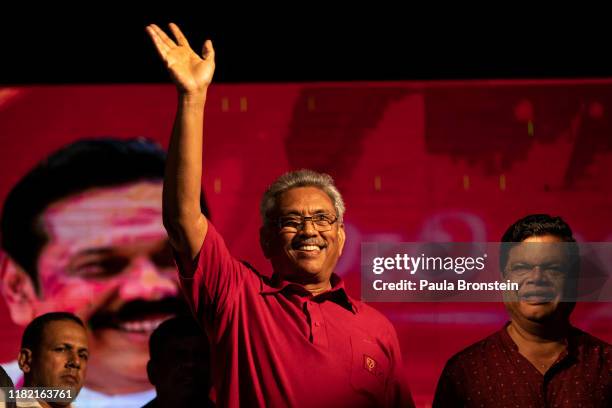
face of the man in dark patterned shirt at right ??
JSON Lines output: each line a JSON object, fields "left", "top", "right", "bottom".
{"left": 505, "top": 235, "right": 573, "bottom": 323}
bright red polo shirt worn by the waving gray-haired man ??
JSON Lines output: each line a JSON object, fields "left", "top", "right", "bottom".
{"left": 181, "top": 223, "right": 413, "bottom": 407}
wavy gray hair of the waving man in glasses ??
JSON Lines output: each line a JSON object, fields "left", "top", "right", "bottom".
{"left": 259, "top": 169, "right": 346, "bottom": 225}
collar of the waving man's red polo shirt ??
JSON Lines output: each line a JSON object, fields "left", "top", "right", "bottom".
{"left": 260, "top": 273, "right": 358, "bottom": 314}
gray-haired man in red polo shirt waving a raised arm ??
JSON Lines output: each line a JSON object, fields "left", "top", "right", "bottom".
{"left": 147, "top": 24, "right": 413, "bottom": 407}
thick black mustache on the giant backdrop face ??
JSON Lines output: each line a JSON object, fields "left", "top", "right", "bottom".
{"left": 88, "top": 297, "right": 191, "bottom": 329}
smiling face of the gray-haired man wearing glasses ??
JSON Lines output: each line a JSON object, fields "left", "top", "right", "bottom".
{"left": 262, "top": 187, "right": 345, "bottom": 284}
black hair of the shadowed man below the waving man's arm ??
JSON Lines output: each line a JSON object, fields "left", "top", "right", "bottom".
{"left": 149, "top": 315, "right": 208, "bottom": 361}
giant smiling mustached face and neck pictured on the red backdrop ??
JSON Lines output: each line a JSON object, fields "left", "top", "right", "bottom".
{"left": 9, "top": 182, "right": 181, "bottom": 393}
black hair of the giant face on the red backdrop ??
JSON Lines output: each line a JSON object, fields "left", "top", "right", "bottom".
{"left": 0, "top": 137, "right": 209, "bottom": 289}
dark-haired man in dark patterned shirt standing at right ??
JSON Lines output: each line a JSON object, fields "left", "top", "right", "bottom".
{"left": 433, "top": 214, "right": 612, "bottom": 408}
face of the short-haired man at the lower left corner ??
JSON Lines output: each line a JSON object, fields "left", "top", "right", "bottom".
{"left": 20, "top": 320, "right": 89, "bottom": 395}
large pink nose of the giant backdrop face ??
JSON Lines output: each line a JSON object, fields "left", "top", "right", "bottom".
{"left": 119, "top": 257, "right": 178, "bottom": 300}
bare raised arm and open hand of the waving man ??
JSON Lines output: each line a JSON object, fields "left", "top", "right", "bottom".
{"left": 146, "top": 23, "right": 215, "bottom": 270}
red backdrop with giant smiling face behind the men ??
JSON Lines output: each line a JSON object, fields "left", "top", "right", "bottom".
{"left": 0, "top": 80, "right": 612, "bottom": 405}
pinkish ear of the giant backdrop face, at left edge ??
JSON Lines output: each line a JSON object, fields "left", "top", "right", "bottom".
{"left": 0, "top": 254, "right": 38, "bottom": 326}
